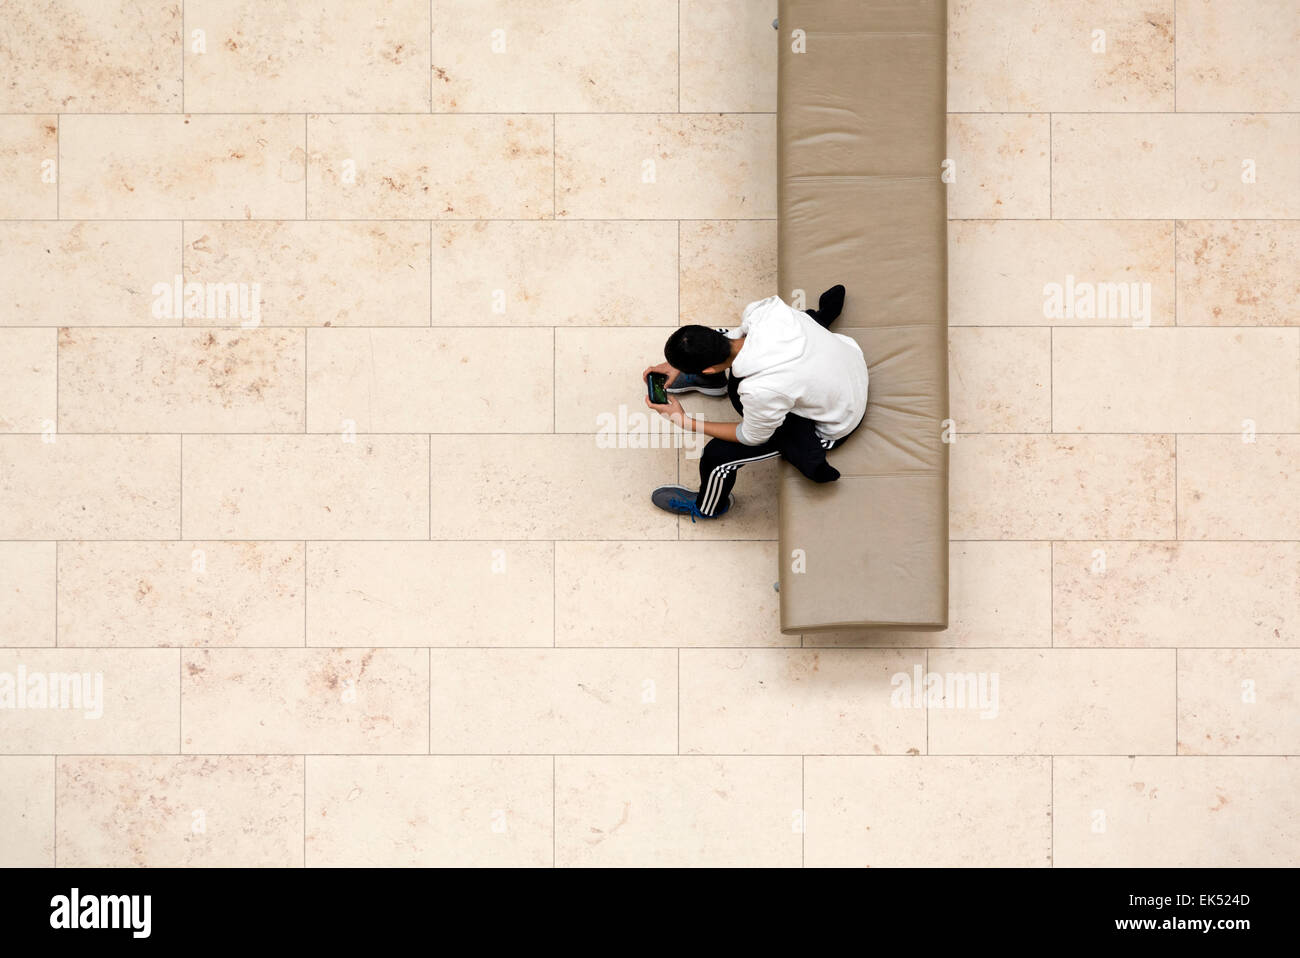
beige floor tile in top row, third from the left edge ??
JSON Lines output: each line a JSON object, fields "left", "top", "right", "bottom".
{"left": 433, "top": 0, "right": 677, "bottom": 113}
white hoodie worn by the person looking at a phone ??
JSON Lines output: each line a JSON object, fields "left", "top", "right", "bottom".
{"left": 727, "top": 296, "right": 867, "bottom": 446}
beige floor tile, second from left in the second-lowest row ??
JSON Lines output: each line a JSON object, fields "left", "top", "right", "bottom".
{"left": 181, "top": 649, "right": 429, "bottom": 754}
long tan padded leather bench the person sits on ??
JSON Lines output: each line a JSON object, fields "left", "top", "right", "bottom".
{"left": 777, "top": 0, "right": 948, "bottom": 633}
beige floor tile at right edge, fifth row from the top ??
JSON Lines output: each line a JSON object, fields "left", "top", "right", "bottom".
{"left": 1178, "top": 435, "right": 1300, "bottom": 539}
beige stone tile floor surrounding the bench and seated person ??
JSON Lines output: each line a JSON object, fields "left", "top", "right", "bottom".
{"left": 0, "top": 0, "right": 1300, "bottom": 866}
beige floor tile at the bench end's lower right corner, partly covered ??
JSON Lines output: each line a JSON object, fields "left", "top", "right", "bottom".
{"left": 803, "top": 542, "right": 1052, "bottom": 649}
